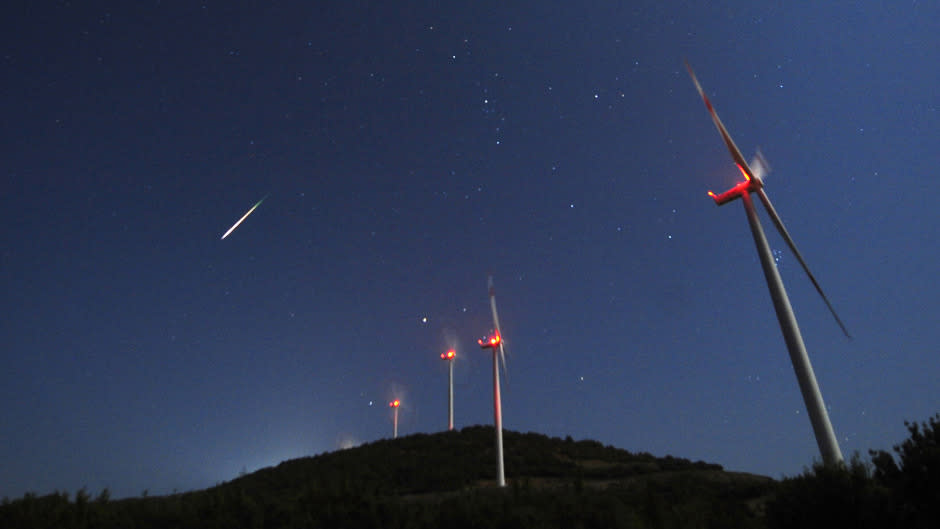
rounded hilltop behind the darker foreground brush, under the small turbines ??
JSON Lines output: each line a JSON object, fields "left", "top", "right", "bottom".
{"left": 223, "top": 426, "right": 740, "bottom": 495}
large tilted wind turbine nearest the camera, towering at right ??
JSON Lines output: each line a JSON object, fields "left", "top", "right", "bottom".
{"left": 685, "top": 62, "right": 852, "bottom": 465}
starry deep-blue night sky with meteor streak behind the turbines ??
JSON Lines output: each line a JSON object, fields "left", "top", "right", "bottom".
{"left": 0, "top": 0, "right": 940, "bottom": 498}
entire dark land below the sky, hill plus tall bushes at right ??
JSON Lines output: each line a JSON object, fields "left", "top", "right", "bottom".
{"left": 0, "top": 415, "right": 940, "bottom": 529}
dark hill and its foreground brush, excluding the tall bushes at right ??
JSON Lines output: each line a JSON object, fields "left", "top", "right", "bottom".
{"left": 0, "top": 426, "right": 776, "bottom": 528}
